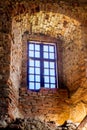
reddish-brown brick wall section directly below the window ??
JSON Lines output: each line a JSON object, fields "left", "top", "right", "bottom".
{"left": 19, "top": 87, "right": 69, "bottom": 123}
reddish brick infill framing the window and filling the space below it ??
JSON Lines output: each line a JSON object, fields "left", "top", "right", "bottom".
{"left": 19, "top": 31, "right": 69, "bottom": 124}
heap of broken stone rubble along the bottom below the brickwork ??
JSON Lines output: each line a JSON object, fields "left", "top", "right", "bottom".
{"left": 1, "top": 118, "right": 77, "bottom": 130}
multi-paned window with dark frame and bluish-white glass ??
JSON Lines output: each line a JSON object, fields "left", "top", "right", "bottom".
{"left": 27, "top": 41, "right": 57, "bottom": 90}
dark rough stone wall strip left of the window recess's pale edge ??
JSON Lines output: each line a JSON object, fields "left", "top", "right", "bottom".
{"left": 0, "top": 1, "right": 11, "bottom": 119}
